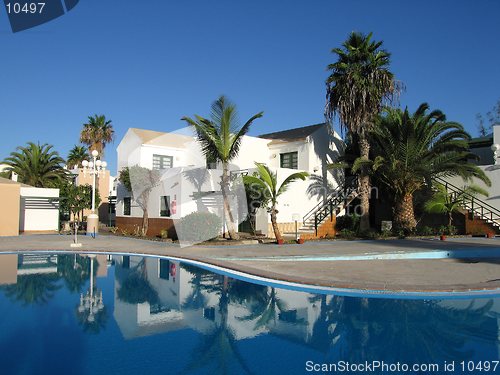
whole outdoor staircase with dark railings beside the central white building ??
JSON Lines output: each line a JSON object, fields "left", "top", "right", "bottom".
{"left": 299, "top": 177, "right": 358, "bottom": 235}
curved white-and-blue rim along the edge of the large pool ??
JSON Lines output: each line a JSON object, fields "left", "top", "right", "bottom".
{"left": 0, "top": 249, "right": 500, "bottom": 300}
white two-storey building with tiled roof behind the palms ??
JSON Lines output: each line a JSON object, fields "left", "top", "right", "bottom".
{"left": 116, "top": 124, "right": 342, "bottom": 239}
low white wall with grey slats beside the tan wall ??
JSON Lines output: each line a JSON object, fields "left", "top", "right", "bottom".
{"left": 19, "top": 187, "right": 59, "bottom": 231}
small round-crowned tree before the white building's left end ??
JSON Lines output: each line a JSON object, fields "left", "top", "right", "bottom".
{"left": 118, "top": 165, "right": 161, "bottom": 236}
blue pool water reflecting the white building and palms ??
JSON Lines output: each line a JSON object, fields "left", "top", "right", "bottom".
{"left": 0, "top": 254, "right": 500, "bottom": 374}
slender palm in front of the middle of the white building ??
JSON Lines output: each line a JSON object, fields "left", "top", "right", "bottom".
{"left": 182, "top": 96, "right": 263, "bottom": 239}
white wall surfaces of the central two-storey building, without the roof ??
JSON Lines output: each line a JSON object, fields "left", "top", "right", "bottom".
{"left": 117, "top": 127, "right": 341, "bottom": 223}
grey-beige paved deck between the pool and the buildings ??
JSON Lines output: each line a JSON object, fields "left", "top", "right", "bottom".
{"left": 0, "top": 235, "right": 500, "bottom": 294}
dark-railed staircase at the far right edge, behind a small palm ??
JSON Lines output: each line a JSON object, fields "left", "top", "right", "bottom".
{"left": 435, "top": 177, "right": 500, "bottom": 230}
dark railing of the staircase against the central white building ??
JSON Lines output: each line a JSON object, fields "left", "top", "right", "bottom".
{"left": 303, "top": 177, "right": 358, "bottom": 235}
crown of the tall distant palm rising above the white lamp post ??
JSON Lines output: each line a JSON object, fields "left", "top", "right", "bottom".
{"left": 80, "top": 115, "right": 115, "bottom": 156}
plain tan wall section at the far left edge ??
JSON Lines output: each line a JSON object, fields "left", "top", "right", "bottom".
{"left": 0, "top": 182, "right": 20, "bottom": 236}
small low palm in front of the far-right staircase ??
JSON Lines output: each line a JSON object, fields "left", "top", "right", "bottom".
{"left": 424, "top": 184, "right": 489, "bottom": 228}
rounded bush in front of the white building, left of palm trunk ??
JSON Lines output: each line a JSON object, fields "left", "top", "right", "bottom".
{"left": 175, "top": 212, "right": 222, "bottom": 242}
